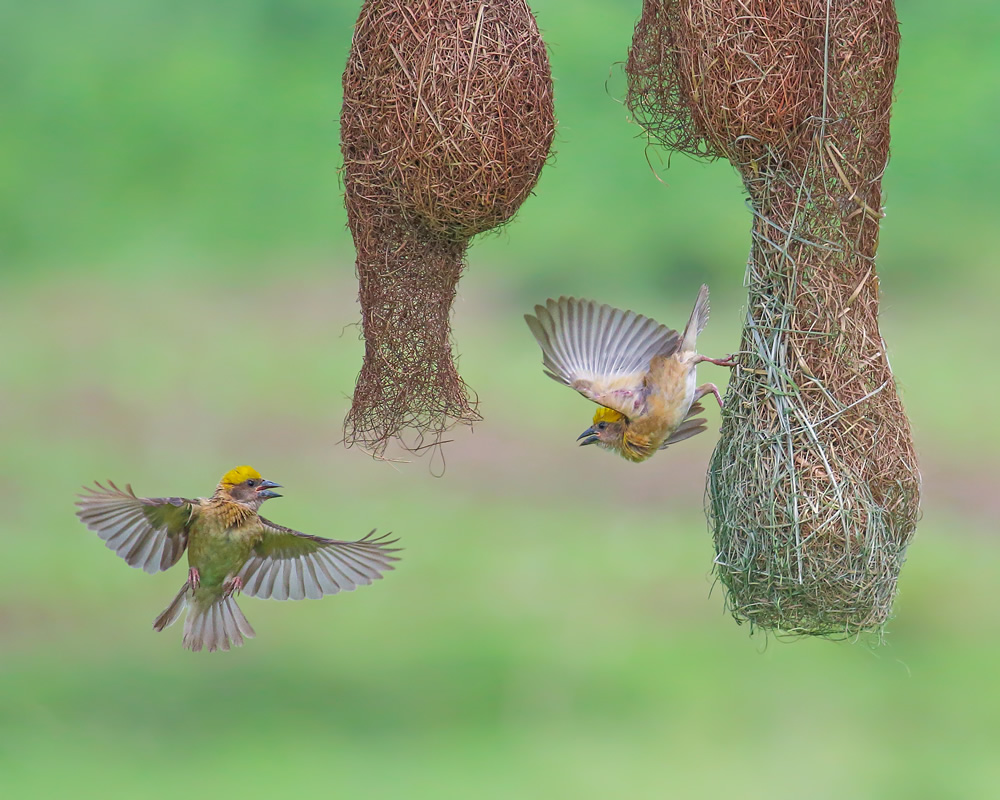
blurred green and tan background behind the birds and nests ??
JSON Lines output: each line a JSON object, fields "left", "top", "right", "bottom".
{"left": 0, "top": 0, "right": 1000, "bottom": 798}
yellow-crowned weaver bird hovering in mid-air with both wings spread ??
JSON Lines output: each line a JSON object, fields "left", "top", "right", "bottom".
{"left": 76, "top": 467, "right": 398, "bottom": 651}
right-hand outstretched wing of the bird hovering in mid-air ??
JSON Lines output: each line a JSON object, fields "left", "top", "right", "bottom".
{"left": 239, "top": 517, "right": 399, "bottom": 600}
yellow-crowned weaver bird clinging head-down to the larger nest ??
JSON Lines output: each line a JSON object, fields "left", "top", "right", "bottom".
{"left": 524, "top": 286, "right": 734, "bottom": 461}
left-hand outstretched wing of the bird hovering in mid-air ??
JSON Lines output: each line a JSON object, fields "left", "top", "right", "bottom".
{"left": 76, "top": 481, "right": 197, "bottom": 573}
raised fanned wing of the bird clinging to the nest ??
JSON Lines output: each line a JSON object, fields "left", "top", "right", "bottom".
{"left": 524, "top": 297, "right": 680, "bottom": 417}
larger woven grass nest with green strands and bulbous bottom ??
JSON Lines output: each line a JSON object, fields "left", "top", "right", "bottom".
{"left": 627, "top": 0, "right": 920, "bottom": 636}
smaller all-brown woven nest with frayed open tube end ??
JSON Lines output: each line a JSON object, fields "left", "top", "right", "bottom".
{"left": 341, "top": 0, "right": 555, "bottom": 454}
